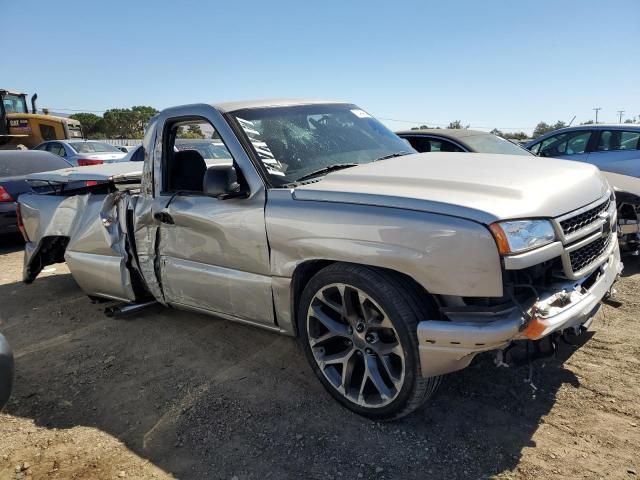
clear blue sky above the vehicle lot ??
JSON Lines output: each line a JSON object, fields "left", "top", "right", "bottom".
{"left": 0, "top": 0, "right": 640, "bottom": 131}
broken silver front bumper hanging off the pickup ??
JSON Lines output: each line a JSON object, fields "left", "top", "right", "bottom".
{"left": 418, "top": 242, "right": 622, "bottom": 377}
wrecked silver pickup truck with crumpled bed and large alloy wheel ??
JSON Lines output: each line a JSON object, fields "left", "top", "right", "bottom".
{"left": 19, "top": 101, "right": 622, "bottom": 419}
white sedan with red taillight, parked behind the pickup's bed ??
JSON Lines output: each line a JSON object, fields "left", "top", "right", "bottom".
{"left": 35, "top": 140, "right": 126, "bottom": 167}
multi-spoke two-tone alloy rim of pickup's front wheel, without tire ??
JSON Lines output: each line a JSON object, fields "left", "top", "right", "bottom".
{"left": 307, "top": 283, "right": 405, "bottom": 408}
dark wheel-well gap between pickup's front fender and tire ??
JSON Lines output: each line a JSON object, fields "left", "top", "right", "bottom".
{"left": 291, "top": 260, "right": 439, "bottom": 335}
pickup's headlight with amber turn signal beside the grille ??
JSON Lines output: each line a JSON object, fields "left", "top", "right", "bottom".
{"left": 489, "top": 220, "right": 556, "bottom": 255}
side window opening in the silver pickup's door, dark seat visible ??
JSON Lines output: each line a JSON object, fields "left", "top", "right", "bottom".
{"left": 164, "top": 119, "right": 233, "bottom": 193}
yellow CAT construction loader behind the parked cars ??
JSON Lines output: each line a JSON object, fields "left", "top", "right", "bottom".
{"left": 0, "top": 88, "right": 83, "bottom": 150}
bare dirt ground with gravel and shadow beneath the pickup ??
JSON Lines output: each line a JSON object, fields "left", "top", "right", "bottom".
{"left": 0, "top": 234, "right": 640, "bottom": 480}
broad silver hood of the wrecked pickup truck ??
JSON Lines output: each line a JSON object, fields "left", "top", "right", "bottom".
{"left": 292, "top": 153, "right": 609, "bottom": 224}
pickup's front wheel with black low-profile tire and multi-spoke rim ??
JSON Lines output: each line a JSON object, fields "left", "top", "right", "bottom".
{"left": 297, "top": 264, "right": 440, "bottom": 420}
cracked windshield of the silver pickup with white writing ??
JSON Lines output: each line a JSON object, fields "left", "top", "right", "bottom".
{"left": 233, "top": 104, "right": 414, "bottom": 186}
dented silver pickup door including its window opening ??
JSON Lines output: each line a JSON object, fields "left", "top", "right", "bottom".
{"left": 153, "top": 111, "right": 274, "bottom": 325}
